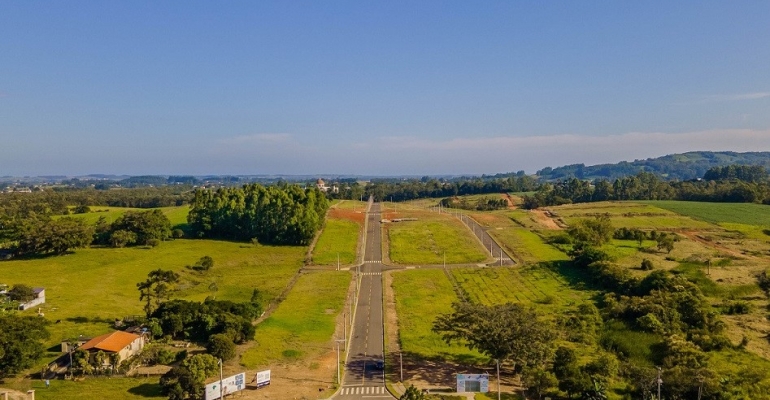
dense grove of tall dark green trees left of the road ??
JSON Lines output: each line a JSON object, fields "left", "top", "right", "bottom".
{"left": 187, "top": 184, "right": 329, "bottom": 245}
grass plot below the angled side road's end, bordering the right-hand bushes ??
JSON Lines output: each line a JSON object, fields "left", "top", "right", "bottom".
{"left": 452, "top": 265, "right": 590, "bottom": 308}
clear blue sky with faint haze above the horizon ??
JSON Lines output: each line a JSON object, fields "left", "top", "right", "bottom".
{"left": 0, "top": 1, "right": 770, "bottom": 176}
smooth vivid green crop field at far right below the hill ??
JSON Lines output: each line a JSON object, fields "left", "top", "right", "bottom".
{"left": 644, "top": 201, "right": 770, "bottom": 226}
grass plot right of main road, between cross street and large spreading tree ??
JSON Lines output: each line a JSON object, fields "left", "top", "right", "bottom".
{"left": 393, "top": 269, "right": 487, "bottom": 363}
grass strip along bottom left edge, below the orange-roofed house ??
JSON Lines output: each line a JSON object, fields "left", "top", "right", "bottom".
{"left": 2, "top": 376, "right": 166, "bottom": 400}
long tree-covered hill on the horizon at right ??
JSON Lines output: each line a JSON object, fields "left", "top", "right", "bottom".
{"left": 537, "top": 151, "right": 770, "bottom": 180}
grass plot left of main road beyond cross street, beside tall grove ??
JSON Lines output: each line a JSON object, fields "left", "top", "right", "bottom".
{"left": 312, "top": 202, "right": 365, "bottom": 265}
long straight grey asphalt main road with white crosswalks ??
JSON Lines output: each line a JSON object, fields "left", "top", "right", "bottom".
{"left": 334, "top": 203, "right": 393, "bottom": 400}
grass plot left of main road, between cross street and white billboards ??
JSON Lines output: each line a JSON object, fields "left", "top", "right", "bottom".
{"left": 241, "top": 271, "right": 351, "bottom": 368}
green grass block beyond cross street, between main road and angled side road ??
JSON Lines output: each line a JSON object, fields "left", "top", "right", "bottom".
{"left": 387, "top": 213, "right": 487, "bottom": 264}
